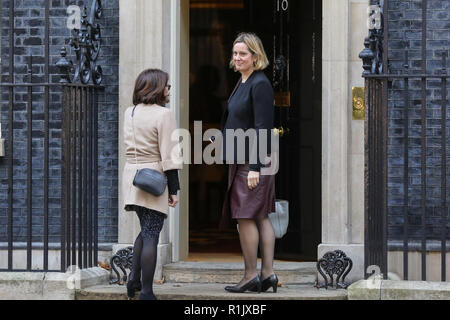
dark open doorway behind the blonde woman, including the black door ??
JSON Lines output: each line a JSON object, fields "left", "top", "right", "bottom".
{"left": 189, "top": 0, "right": 322, "bottom": 260}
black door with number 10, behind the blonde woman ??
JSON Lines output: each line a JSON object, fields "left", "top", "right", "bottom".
{"left": 255, "top": 0, "right": 322, "bottom": 260}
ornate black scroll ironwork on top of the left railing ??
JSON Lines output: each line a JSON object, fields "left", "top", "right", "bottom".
{"left": 56, "top": 0, "right": 103, "bottom": 85}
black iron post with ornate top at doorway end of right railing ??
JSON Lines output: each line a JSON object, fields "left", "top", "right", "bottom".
{"left": 360, "top": 1, "right": 388, "bottom": 278}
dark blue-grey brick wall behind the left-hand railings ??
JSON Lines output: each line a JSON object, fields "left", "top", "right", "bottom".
{"left": 0, "top": 0, "right": 119, "bottom": 242}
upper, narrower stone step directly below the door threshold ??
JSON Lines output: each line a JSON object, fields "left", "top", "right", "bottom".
{"left": 163, "top": 261, "right": 317, "bottom": 285}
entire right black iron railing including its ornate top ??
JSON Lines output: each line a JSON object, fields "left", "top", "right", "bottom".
{"left": 360, "top": 0, "right": 450, "bottom": 281}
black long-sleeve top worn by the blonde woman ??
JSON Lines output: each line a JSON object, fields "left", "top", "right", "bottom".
{"left": 221, "top": 71, "right": 274, "bottom": 171}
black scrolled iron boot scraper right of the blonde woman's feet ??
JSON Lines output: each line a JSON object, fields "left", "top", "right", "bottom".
{"left": 315, "top": 250, "right": 353, "bottom": 289}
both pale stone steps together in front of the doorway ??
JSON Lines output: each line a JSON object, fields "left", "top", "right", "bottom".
{"left": 75, "top": 260, "right": 347, "bottom": 300}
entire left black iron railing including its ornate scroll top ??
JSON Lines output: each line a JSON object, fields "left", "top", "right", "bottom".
{"left": 0, "top": 0, "right": 104, "bottom": 272}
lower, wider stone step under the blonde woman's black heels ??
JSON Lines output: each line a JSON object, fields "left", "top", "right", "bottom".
{"left": 75, "top": 283, "right": 347, "bottom": 300}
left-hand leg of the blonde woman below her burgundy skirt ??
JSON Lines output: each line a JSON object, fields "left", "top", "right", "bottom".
{"left": 238, "top": 219, "right": 259, "bottom": 287}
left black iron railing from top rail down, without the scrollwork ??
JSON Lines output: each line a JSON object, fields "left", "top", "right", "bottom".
{"left": 0, "top": 70, "right": 103, "bottom": 271}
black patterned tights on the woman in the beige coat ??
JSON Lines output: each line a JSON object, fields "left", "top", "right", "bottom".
{"left": 130, "top": 206, "right": 165, "bottom": 300}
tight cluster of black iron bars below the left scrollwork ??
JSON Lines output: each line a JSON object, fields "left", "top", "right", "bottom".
{"left": 61, "top": 84, "right": 101, "bottom": 268}
